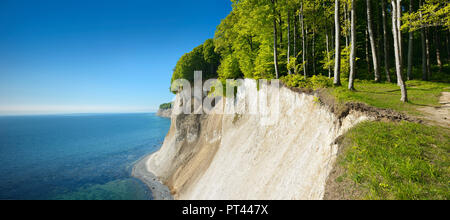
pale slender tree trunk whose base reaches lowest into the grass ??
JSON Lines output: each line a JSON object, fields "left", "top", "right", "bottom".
{"left": 392, "top": 0, "right": 408, "bottom": 102}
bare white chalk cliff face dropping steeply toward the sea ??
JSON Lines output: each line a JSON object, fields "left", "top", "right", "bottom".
{"left": 147, "top": 80, "right": 369, "bottom": 200}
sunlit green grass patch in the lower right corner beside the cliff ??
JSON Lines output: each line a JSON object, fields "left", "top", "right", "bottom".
{"left": 335, "top": 122, "right": 450, "bottom": 200}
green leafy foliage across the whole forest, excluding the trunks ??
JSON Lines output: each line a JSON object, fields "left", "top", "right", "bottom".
{"left": 172, "top": 0, "right": 450, "bottom": 99}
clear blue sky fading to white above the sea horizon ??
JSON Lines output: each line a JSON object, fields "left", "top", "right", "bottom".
{"left": 0, "top": 0, "right": 231, "bottom": 114}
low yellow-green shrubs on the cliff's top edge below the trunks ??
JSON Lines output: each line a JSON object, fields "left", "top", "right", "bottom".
{"left": 280, "top": 74, "right": 333, "bottom": 90}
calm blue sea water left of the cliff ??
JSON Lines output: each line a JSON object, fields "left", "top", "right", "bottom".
{"left": 0, "top": 114, "right": 170, "bottom": 200}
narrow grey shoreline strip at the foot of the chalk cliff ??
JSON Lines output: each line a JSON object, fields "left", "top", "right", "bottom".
{"left": 131, "top": 152, "right": 173, "bottom": 200}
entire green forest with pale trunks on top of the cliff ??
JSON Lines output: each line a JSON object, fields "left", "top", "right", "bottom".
{"left": 172, "top": 0, "right": 450, "bottom": 102}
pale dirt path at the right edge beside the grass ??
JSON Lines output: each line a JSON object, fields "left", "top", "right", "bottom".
{"left": 419, "top": 92, "right": 450, "bottom": 127}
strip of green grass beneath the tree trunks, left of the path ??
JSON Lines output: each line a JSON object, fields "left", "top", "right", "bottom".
{"left": 329, "top": 80, "right": 450, "bottom": 116}
